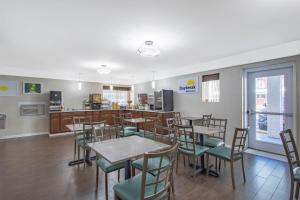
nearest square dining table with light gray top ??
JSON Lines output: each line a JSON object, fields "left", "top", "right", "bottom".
{"left": 88, "top": 135, "right": 170, "bottom": 179}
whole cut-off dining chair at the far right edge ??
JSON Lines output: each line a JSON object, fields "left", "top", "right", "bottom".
{"left": 280, "top": 129, "right": 300, "bottom": 200}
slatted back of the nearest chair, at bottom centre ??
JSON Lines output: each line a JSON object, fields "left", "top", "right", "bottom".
{"left": 140, "top": 144, "right": 178, "bottom": 200}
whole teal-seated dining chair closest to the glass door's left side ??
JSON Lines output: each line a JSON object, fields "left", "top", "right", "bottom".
{"left": 206, "top": 128, "right": 248, "bottom": 189}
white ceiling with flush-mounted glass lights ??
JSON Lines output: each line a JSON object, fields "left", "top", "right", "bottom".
{"left": 0, "top": 0, "right": 300, "bottom": 84}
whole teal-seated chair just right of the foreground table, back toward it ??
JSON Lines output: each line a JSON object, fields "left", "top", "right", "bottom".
{"left": 175, "top": 125, "right": 209, "bottom": 177}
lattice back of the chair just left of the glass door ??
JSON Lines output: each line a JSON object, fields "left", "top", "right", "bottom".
{"left": 231, "top": 128, "right": 248, "bottom": 159}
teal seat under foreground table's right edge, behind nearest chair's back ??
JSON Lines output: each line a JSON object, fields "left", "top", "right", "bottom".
{"left": 131, "top": 158, "right": 169, "bottom": 175}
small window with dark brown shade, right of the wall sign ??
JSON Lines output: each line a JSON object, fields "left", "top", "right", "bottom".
{"left": 202, "top": 74, "right": 220, "bottom": 102}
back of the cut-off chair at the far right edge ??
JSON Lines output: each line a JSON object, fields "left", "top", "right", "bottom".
{"left": 280, "top": 129, "right": 300, "bottom": 178}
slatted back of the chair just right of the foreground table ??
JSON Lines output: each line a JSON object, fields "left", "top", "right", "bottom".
{"left": 175, "top": 125, "right": 196, "bottom": 155}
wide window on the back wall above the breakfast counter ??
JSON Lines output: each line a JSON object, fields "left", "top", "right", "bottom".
{"left": 103, "top": 86, "right": 130, "bottom": 106}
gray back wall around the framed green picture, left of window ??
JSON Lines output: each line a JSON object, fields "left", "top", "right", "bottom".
{"left": 0, "top": 75, "right": 102, "bottom": 138}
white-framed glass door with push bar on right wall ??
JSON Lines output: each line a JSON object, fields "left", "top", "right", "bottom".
{"left": 247, "top": 67, "right": 293, "bottom": 154}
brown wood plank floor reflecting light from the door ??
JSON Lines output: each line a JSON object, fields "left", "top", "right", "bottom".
{"left": 0, "top": 136, "right": 290, "bottom": 200}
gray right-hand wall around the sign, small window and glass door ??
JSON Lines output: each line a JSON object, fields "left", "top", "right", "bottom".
{"left": 135, "top": 56, "right": 300, "bottom": 145}
